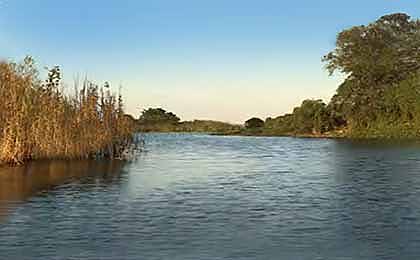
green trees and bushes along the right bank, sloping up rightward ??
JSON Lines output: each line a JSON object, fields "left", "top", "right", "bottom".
{"left": 243, "top": 13, "right": 420, "bottom": 138}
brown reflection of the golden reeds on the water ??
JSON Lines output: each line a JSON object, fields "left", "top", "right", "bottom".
{"left": 0, "top": 160, "right": 125, "bottom": 218}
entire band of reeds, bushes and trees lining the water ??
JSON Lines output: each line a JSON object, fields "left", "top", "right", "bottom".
{"left": 13, "top": 13, "right": 420, "bottom": 146}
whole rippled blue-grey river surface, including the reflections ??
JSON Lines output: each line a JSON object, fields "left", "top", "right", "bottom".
{"left": 0, "top": 134, "right": 420, "bottom": 260}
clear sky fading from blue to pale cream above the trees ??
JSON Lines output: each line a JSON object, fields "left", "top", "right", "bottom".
{"left": 0, "top": 0, "right": 420, "bottom": 123}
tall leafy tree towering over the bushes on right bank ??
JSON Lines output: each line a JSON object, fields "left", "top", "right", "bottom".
{"left": 323, "top": 13, "right": 420, "bottom": 128}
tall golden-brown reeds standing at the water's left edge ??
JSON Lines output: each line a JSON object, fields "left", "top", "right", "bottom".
{"left": 0, "top": 57, "right": 135, "bottom": 164}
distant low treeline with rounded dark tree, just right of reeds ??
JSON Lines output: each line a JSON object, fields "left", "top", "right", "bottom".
{"left": 137, "top": 108, "right": 241, "bottom": 133}
